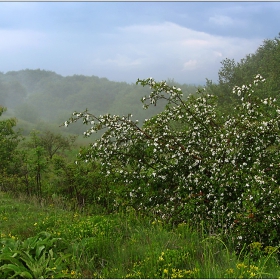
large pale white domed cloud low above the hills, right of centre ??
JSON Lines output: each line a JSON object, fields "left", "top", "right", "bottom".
{"left": 86, "top": 22, "right": 262, "bottom": 83}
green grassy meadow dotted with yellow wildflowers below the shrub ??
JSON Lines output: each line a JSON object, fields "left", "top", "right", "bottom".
{"left": 0, "top": 192, "right": 280, "bottom": 278}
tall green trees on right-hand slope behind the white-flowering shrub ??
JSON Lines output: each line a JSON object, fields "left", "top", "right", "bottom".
{"left": 212, "top": 36, "right": 280, "bottom": 114}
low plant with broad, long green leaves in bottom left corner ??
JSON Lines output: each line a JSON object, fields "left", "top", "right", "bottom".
{"left": 0, "top": 232, "right": 75, "bottom": 279}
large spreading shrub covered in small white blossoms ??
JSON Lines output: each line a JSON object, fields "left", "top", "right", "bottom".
{"left": 65, "top": 75, "right": 280, "bottom": 250}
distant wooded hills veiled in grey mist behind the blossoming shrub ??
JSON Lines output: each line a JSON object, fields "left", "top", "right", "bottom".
{"left": 0, "top": 69, "right": 197, "bottom": 135}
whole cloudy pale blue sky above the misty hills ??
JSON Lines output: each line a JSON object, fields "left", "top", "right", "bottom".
{"left": 0, "top": 1, "right": 280, "bottom": 85}
